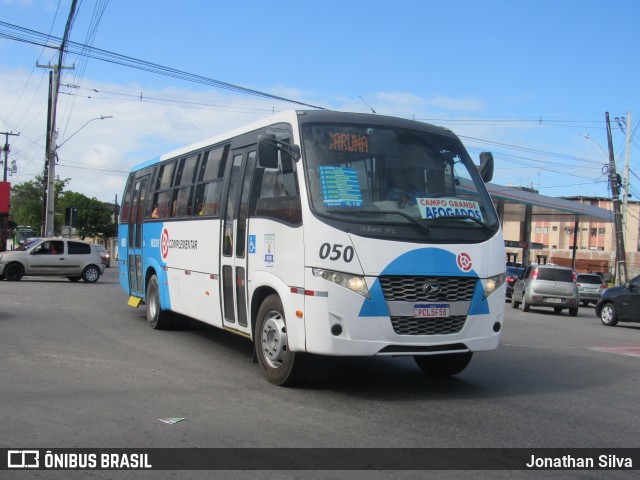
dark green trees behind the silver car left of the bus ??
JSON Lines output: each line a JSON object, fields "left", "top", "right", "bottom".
{"left": 11, "top": 176, "right": 114, "bottom": 238}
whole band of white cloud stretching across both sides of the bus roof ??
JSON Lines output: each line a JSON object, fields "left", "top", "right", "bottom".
{"left": 0, "top": 66, "right": 608, "bottom": 202}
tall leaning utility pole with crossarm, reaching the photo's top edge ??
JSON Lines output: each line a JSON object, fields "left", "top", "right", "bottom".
{"left": 37, "top": 0, "right": 78, "bottom": 237}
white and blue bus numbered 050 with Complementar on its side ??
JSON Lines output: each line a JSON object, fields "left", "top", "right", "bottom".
{"left": 119, "top": 110, "right": 505, "bottom": 385}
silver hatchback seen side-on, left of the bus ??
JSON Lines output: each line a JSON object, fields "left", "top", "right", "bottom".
{"left": 0, "top": 238, "right": 104, "bottom": 283}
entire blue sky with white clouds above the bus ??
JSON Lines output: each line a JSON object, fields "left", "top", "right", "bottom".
{"left": 0, "top": 0, "right": 640, "bottom": 202}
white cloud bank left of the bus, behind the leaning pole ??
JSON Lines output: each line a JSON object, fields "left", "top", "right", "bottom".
{"left": 0, "top": 67, "right": 293, "bottom": 201}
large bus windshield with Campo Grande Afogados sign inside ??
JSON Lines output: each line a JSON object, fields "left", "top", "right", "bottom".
{"left": 302, "top": 123, "right": 499, "bottom": 241}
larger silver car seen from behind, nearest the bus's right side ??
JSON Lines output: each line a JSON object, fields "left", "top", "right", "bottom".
{"left": 511, "top": 265, "right": 580, "bottom": 317}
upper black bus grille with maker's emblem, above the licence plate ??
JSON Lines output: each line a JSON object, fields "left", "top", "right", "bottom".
{"left": 380, "top": 275, "right": 477, "bottom": 302}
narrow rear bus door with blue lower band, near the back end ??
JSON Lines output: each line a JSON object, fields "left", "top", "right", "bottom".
{"left": 127, "top": 175, "right": 149, "bottom": 297}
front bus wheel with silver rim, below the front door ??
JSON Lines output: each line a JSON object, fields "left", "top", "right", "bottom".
{"left": 255, "top": 295, "right": 301, "bottom": 386}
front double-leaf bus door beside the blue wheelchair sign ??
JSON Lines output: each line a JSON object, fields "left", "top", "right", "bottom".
{"left": 220, "top": 146, "right": 256, "bottom": 335}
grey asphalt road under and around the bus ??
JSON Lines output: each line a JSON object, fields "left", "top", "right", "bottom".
{"left": 0, "top": 268, "right": 640, "bottom": 479}
